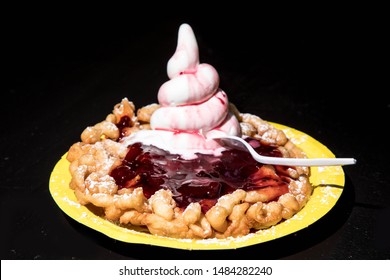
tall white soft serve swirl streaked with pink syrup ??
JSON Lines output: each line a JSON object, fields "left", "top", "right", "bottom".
{"left": 123, "top": 24, "right": 241, "bottom": 158}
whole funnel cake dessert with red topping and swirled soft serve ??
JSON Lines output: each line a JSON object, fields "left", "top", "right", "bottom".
{"left": 67, "top": 24, "right": 312, "bottom": 239}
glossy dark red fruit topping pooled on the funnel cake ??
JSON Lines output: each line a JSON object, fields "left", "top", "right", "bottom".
{"left": 110, "top": 138, "right": 290, "bottom": 212}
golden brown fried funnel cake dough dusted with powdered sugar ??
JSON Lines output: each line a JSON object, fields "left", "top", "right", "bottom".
{"left": 67, "top": 98, "right": 312, "bottom": 239}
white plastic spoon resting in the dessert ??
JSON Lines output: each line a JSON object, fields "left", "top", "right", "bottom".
{"left": 212, "top": 135, "right": 356, "bottom": 166}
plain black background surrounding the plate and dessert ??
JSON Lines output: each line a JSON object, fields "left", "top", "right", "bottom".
{"left": 0, "top": 9, "right": 390, "bottom": 259}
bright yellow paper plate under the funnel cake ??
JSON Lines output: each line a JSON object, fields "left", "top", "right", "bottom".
{"left": 49, "top": 123, "right": 345, "bottom": 250}
